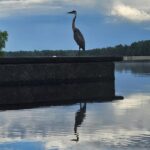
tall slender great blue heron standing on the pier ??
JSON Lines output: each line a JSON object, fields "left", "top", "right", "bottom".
{"left": 68, "top": 10, "right": 85, "bottom": 51}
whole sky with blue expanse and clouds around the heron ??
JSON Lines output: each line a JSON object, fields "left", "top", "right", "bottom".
{"left": 0, "top": 0, "right": 150, "bottom": 51}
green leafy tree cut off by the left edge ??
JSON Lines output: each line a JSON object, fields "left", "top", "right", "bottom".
{"left": 0, "top": 31, "right": 8, "bottom": 51}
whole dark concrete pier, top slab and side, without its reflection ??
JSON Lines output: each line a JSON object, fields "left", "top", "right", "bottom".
{"left": 0, "top": 57, "right": 121, "bottom": 86}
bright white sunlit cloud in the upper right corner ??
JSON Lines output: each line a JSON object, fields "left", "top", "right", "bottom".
{"left": 92, "top": 0, "right": 150, "bottom": 23}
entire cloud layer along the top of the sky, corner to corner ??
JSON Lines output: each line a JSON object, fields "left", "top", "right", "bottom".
{"left": 0, "top": 0, "right": 150, "bottom": 23}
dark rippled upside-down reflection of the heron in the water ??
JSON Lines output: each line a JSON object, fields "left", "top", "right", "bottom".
{"left": 72, "top": 103, "right": 86, "bottom": 142}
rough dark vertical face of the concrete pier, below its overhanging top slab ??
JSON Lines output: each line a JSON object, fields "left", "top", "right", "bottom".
{"left": 0, "top": 62, "right": 114, "bottom": 85}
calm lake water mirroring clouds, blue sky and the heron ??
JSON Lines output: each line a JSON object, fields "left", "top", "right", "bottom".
{"left": 0, "top": 63, "right": 150, "bottom": 150}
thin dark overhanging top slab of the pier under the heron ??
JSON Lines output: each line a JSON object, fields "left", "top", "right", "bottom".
{"left": 0, "top": 56, "right": 123, "bottom": 64}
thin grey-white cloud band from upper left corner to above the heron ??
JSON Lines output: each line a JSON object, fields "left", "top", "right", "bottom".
{"left": 0, "top": 0, "right": 96, "bottom": 17}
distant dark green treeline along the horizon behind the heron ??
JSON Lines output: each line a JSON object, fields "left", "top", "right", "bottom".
{"left": 5, "top": 40, "right": 150, "bottom": 57}
